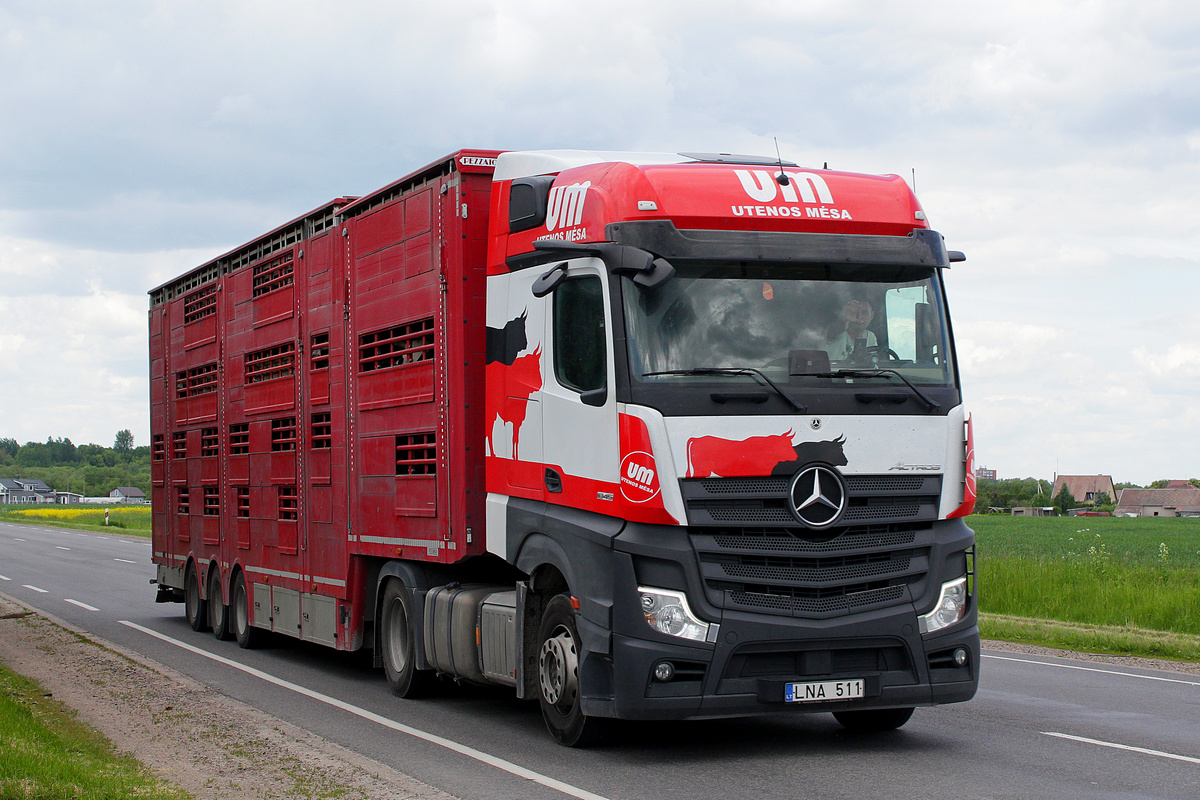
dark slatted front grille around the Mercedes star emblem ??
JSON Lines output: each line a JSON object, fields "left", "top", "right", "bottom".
{"left": 680, "top": 474, "right": 942, "bottom": 618}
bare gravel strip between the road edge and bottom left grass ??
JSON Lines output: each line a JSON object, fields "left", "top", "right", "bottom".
{"left": 0, "top": 594, "right": 454, "bottom": 800}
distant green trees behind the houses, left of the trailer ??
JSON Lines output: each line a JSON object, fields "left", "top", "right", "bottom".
{"left": 0, "top": 429, "right": 150, "bottom": 497}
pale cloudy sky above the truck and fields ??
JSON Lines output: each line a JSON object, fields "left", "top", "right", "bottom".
{"left": 0, "top": 0, "right": 1200, "bottom": 483}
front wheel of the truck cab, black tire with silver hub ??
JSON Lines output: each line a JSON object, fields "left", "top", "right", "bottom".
{"left": 538, "top": 595, "right": 611, "bottom": 747}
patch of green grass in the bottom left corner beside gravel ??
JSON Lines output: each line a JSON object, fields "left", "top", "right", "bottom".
{"left": 0, "top": 664, "right": 191, "bottom": 800}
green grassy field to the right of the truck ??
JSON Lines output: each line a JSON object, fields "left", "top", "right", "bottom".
{"left": 968, "top": 515, "right": 1200, "bottom": 661}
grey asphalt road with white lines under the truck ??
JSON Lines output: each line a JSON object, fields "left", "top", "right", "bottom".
{"left": 0, "top": 523, "right": 1200, "bottom": 800}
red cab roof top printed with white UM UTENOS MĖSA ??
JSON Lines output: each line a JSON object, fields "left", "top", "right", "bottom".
{"left": 488, "top": 154, "right": 926, "bottom": 273}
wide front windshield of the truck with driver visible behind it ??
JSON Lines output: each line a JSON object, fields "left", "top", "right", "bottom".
{"left": 622, "top": 261, "right": 954, "bottom": 386}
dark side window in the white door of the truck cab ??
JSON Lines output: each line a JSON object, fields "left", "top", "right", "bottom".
{"left": 554, "top": 277, "right": 608, "bottom": 392}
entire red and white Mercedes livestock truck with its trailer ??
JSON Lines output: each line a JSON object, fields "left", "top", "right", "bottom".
{"left": 150, "top": 150, "right": 979, "bottom": 745}
